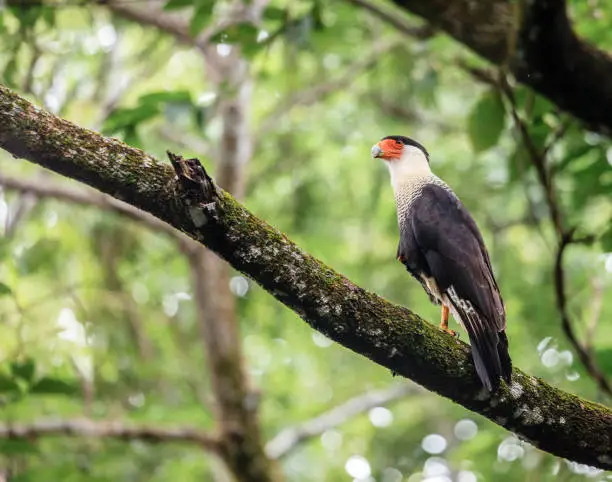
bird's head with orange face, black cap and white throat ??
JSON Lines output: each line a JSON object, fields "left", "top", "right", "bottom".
{"left": 371, "top": 136, "right": 431, "bottom": 182}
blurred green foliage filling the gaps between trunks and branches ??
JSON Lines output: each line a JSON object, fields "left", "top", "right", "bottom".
{"left": 0, "top": 0, "right": 612, "bottom": 482}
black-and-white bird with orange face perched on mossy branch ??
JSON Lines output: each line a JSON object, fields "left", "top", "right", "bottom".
{"left": 371, "top": 136, "right": 512, "bottom": 392}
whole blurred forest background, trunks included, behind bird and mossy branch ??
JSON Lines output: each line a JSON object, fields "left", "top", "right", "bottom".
{"left": 0, "top": 0, "right": 612, "bottom": 482}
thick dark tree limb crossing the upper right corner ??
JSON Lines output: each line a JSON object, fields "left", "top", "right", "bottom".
{"left": 394, "top": 0, "right": 612, "bottom": 135}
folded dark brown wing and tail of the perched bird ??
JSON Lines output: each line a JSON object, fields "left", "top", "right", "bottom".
{"left": 411, "top": 184, "right": 512, "bottom": 389}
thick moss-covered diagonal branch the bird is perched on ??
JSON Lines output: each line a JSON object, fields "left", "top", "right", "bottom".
{"left": 0, "top": 86, "right": 612, "bottom": 470}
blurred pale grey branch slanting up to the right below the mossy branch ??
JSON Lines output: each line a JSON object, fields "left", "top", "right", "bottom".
{"left": 266, "top": 384, "right": 418, "bottom": 459}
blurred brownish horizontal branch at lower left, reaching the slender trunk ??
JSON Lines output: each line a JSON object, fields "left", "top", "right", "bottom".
{"left": 0, "top": 419, "right": 220, "bottom": 453}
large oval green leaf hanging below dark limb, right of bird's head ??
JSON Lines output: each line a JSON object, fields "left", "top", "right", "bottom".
{"left": 468, "top": 91, "right": 506, "bottom": 152}
